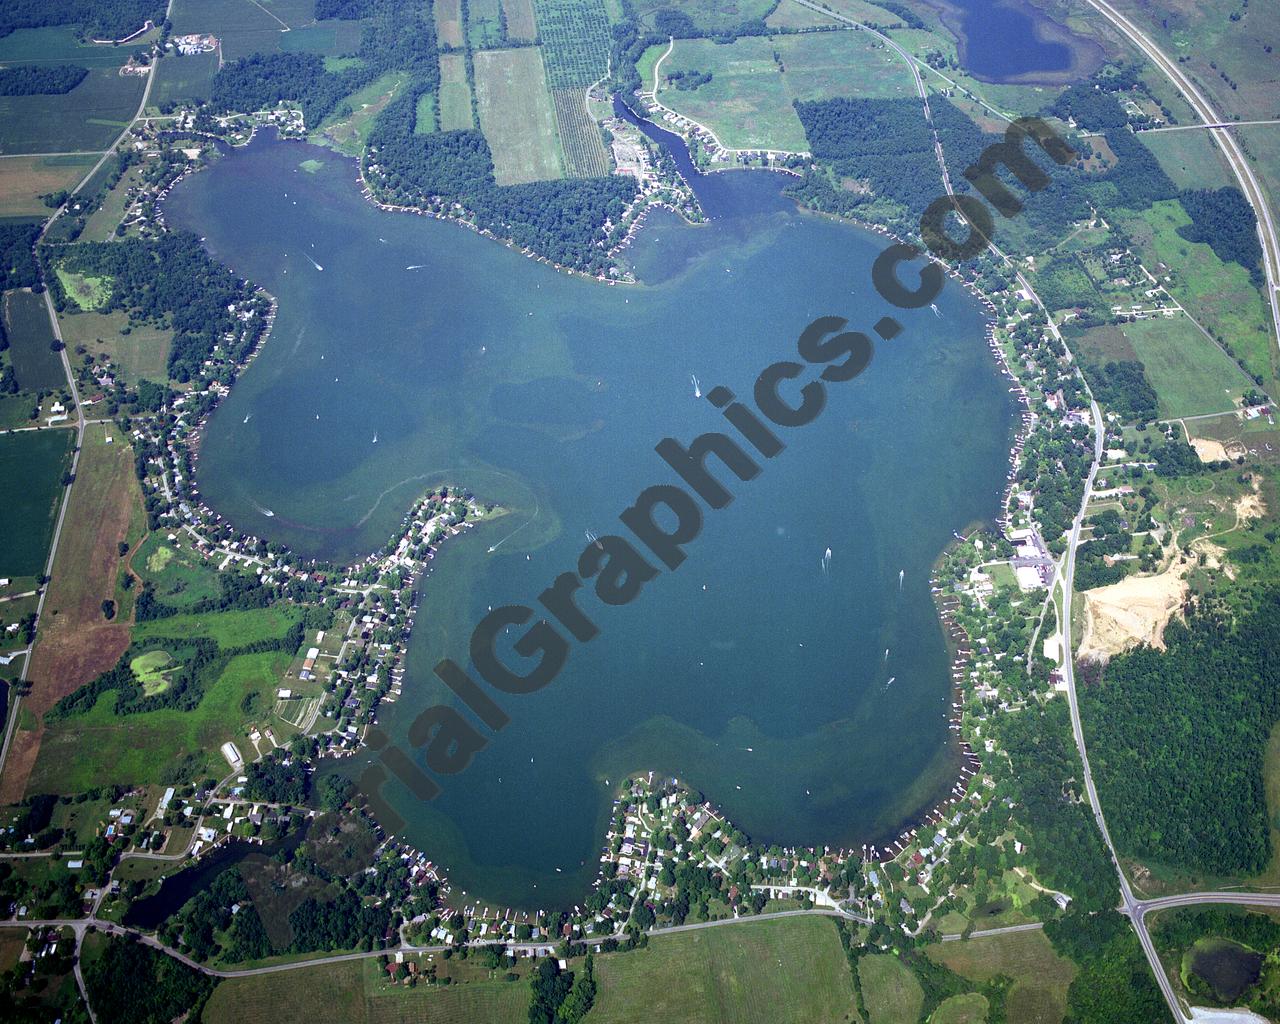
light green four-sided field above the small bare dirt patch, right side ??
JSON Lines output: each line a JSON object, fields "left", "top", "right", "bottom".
{"left": 1124, "top": 316, "right": 1253, "bottom": 419}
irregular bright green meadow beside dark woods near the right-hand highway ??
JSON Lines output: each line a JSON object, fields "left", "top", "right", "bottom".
{"left": 1125, "top": 200, "right": 1276, "bottom": 388}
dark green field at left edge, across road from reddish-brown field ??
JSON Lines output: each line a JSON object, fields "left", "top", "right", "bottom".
{"left": 0, "top": 430, "right": 76, "bottom": 576}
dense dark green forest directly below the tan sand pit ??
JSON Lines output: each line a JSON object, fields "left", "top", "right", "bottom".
{"left": 1080, "top": 589, "right": 1280, "bottom": 876}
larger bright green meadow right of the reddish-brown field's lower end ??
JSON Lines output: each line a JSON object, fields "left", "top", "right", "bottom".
{"left": 29, "top": 652, "right": 289, "bottom": 792}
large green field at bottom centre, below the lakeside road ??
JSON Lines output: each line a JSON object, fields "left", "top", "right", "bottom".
{"left": 591, "top": 918, "right": 855, "bottom": 1024}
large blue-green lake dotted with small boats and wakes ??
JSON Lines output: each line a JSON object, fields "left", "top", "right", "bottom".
{"left": 165, "top": 129, "right": 1015, "bottom": 908}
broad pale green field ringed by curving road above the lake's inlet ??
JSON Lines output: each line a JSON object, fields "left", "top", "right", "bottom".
{"left": 658, "top": 32, "right": 914, "bottom": 152}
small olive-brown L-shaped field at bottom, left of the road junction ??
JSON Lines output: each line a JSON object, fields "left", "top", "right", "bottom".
{"left": 928, "top": 931, "right": 1075, "bottom": 1024}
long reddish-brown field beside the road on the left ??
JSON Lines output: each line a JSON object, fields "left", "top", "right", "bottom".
{"left": 0, "top": 424, "right": 142, "bottom": 803}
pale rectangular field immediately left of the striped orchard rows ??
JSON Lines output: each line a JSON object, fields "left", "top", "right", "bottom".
{"left": 475, "top": 46, "right": 563, "bottom": 184}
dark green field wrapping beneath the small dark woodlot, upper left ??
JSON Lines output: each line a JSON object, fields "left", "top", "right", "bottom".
{"left": 0, "top": 67, "right": 146, "bottom": 154}
